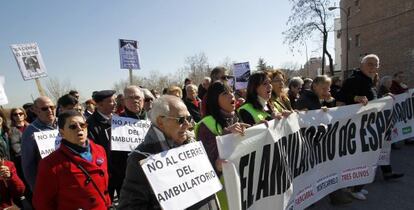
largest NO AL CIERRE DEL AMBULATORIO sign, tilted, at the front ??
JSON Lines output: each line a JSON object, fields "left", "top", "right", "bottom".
{"left": 141, "top": 142, "right": 222, "bottom": 210}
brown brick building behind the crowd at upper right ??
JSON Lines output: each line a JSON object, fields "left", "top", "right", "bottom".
{"left": 340, "top": 0, "right": 414, "bottom": 87}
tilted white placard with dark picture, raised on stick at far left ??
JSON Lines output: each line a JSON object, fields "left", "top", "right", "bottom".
{"left": 10, "top": 43, "right": 47, "bottom": 81}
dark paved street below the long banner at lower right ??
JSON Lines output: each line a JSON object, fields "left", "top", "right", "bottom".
{"left": 314, "top": 142, "right": 414, "bottom": 210}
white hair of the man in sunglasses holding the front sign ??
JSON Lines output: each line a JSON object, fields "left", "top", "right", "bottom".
{"left": 149, "top": 95, "right": 185, "bottom": 125}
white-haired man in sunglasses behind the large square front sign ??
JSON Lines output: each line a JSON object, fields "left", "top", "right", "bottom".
{"left": 119, "top": 95, "right": 219, "bottom": 210}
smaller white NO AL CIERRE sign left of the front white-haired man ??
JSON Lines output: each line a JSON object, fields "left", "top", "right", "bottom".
{"left": 111, "top": 115, "right": 151, "bottom": 152}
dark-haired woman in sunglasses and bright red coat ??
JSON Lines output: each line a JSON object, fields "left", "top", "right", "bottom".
{"left": 33, "top": 110, "right": 111, "bottom": 210}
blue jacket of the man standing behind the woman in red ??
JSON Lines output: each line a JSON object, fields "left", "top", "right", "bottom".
{"left": 22, "top": 119, "right": 56, "bottom": 191}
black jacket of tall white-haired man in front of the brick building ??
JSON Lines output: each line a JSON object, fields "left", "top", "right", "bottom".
{"left": 336, "top": 71, "right": 377, "bottom": 105}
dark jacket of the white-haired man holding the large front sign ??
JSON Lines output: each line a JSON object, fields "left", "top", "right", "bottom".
{"left": 118, "top": 126, "right": 219, "bottom": 210}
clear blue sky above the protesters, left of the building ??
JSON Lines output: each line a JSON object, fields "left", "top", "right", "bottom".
{"left": 0, "top": 0, "right": 333, "bottom": 107}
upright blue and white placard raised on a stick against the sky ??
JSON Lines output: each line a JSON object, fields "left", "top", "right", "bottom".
{"left": 119, "top": 39, "right": 141, "bottom": 69}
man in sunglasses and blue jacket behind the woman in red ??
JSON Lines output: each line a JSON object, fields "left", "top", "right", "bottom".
{"left": 22, "top": 96, "right": 56, "bottom": 191}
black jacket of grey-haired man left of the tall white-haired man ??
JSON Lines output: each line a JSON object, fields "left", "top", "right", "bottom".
{"left": 296, "top": 90, "right": 335, "bottom": 110}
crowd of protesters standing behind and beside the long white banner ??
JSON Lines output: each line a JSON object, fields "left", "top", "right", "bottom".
{"left": 0, "top": 54, "right": 412, "bottom": 210}
